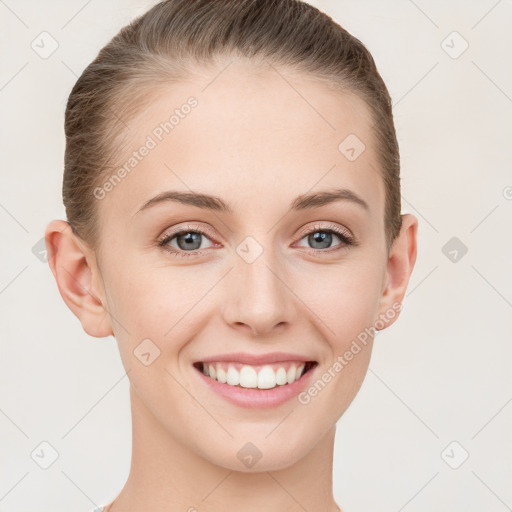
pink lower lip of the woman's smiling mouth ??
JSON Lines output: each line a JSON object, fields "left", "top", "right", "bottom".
{"left": 195, "top": 365, "right": 318, "bottom": 409}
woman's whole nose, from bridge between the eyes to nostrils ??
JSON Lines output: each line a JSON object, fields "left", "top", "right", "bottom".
{"left": 226, "top": 236, "right": 293, "bottom": 335}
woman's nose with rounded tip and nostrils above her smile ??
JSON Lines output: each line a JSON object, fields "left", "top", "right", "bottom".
{"left": 224, "top": 247, "right": 295, "bottom": 336}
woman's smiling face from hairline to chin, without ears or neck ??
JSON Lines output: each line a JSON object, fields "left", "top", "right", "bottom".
{"left": 84, "top": 62, "right": 414, "bottom": 471}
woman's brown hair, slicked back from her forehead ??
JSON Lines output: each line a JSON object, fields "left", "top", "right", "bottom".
{"left": 62, "top": 0, "right": 402, "bottom": 250}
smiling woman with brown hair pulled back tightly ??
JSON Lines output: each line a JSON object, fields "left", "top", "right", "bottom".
{"left": 46, "top": 0, "right": 418, "bottom": 512}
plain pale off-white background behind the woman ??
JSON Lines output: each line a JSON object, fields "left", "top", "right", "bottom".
{"left": 0, "top": 0, "right": 512, "bottom": 512}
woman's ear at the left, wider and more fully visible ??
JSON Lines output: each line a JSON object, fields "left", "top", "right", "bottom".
{"left": 45, "top": 220, "right": 113, "bottom": 338}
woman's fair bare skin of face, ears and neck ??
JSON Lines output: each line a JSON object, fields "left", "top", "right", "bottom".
{"left": 46, "top": 61, "right": 418, "bottom": 512}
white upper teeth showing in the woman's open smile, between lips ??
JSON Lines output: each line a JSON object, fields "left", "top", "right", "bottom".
{"left": 194, "top": 361, "right": 318, "bottom": 389}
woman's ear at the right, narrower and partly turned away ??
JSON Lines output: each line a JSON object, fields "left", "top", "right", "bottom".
{"left": 376, "top": 213, "right": 418, "bottom": 330}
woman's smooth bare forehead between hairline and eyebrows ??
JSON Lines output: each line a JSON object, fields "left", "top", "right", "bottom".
{"left": 96, "top": 58, "right": 384, "bottom": 222}
